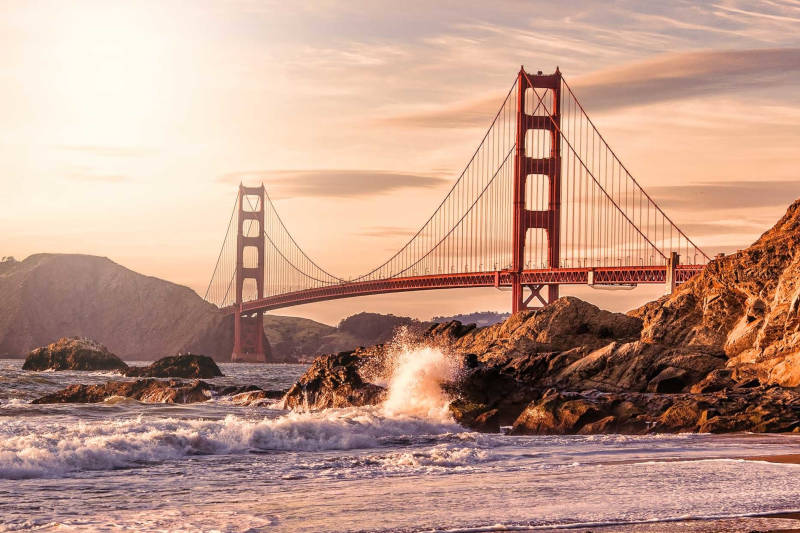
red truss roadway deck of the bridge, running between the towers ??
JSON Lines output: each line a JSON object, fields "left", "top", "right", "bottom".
{"left": 223, "top": 265, "right": 705, "bottom": 314}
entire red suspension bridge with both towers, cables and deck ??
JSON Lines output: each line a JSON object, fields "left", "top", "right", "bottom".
{"left": 204, "top": 68, "right": 709, "bottom": 361}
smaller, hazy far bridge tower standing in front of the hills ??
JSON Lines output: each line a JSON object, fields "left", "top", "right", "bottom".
{"left": 231, "top": 184, "right": 266, "bottom": 363}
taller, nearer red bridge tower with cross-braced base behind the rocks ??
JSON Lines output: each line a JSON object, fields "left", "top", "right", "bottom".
{"left": 511, "top": 67, "right": 561, "bottom": 313}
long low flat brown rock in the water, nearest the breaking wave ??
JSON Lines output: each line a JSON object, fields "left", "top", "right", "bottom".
{"left": 32, "top": 378, "right": 282, "bottom": 405}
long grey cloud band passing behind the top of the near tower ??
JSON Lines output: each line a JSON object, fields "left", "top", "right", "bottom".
{"left": 380, "top": 48, "right": 800, "bottom": 128}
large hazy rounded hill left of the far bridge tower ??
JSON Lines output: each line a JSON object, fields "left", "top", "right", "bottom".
{"left": 0, "top": 254, "right": 241, "bottom": 360}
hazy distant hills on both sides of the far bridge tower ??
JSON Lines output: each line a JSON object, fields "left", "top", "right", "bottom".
{"left": 0, "top": 254, "right": 444, "bottom": 362}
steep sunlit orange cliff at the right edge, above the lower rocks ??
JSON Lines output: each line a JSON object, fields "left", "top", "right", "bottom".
{"left": 630, "top": 200, "right": 800, "bottom": 387}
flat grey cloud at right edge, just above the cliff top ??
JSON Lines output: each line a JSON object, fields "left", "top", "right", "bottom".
{"left": 647, "top": 180, "right": 800, "bottom": 211}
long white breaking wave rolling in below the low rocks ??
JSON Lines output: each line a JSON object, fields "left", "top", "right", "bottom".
{"left": 0, "top": 408, "right": 463, "bottom": 479}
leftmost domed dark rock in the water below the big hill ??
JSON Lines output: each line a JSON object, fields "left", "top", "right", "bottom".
{"left": 22, "top": 337, "right": 128, "bottom": 371}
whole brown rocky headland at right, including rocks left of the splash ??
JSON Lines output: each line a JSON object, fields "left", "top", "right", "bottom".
{"left": 286, "top": 197, "right": 800, "bottom": 434}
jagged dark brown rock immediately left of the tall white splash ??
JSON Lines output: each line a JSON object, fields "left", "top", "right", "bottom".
{"left": 282, "top": 351, "right": 386, "bottom": 410}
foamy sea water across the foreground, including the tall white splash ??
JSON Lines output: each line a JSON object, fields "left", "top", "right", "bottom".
{"left": 0, "top": 346, "right": 800, "bottom": 531}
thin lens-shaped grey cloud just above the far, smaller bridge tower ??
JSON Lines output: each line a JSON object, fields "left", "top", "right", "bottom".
{"left": 218, "top": 169, "right": 452, "bottom": 198}
